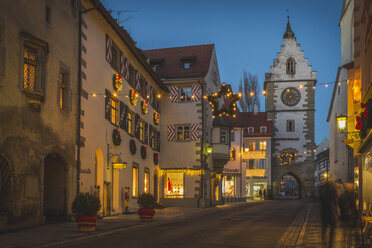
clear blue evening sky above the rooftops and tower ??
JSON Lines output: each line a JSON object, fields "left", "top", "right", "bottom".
{"left": 101, "top": 0, "right": 342, "bottom": 144}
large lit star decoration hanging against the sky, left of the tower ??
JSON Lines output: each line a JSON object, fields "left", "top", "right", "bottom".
{"left": 208, "top": 83, "right": 242, "bottom": 118}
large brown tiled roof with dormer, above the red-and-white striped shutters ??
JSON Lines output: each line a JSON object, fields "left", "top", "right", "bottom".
{"left": 142, "top": 44, "right": 214, "bottom": 79}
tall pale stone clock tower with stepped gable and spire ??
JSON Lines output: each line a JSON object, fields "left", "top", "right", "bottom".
{"left": 264, "top": 17, "right": 316, "bottom": 199}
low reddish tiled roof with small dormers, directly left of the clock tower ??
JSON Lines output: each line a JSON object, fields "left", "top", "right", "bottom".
{"left": 213, "top": 112, "right": 273, "bottom": 137}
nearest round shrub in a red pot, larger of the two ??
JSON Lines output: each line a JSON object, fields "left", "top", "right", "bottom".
{"left": 72, "top": 193, "right": 101, "bottom": 232}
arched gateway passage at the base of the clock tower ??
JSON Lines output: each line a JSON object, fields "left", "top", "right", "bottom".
{"left": 278, "top": 173, "right": 301, "bottom": 199}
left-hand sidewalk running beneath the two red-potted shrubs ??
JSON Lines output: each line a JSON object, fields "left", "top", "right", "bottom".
{"left": 0, "top": 201, "right": 253, "bottom": 248}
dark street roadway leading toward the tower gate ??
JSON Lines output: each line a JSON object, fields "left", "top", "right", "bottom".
{"left": 58, "top": 200, "right": 308, "bottom": 248}
